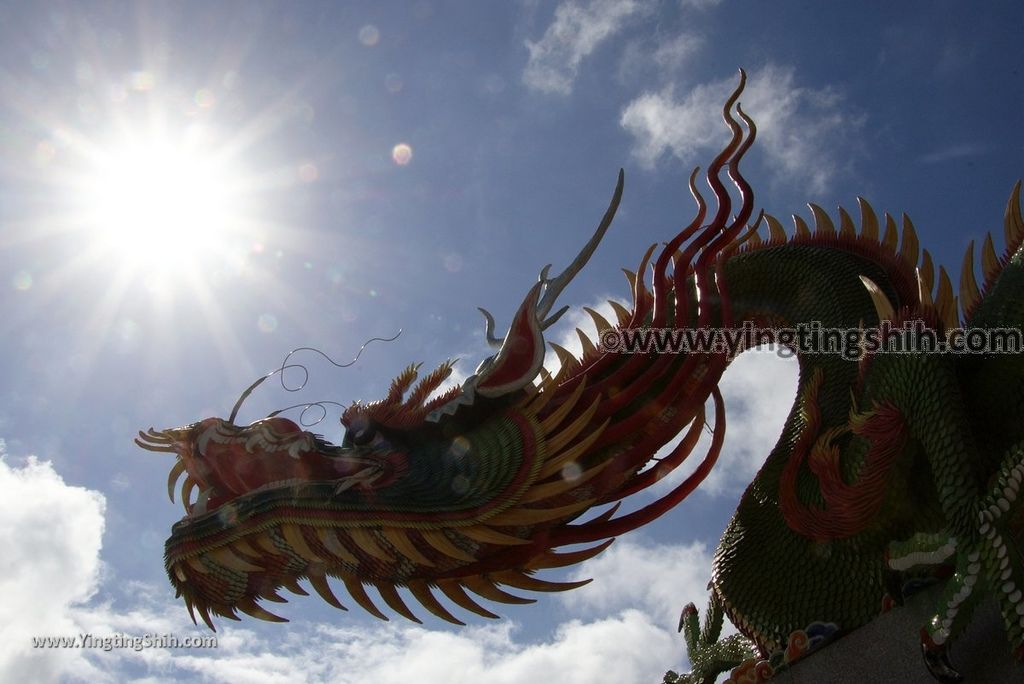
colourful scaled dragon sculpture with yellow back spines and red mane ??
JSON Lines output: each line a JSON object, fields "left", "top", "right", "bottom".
{"left": 137, "top": 73, "right": 1024, "bottom": 682}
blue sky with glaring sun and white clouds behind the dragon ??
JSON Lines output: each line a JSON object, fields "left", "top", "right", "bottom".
{"left": 0, "top": 0, "right": 1024, "bottom": 683}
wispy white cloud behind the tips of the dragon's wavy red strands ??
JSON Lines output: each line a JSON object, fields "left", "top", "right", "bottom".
{"left": 620, "top": 63, "right": 862, "bottom": 193}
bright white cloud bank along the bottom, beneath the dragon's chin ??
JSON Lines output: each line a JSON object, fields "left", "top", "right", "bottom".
{"left": 0, "top": 438, "right": 708, "bottom": 684}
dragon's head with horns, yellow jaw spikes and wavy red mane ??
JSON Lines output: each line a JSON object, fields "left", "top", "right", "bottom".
{"left": 136, "top": 72, "right": 754, "bottom": 629}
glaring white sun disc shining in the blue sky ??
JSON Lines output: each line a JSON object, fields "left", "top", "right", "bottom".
{"left": 80, "top": 126, "right": 242, "bottom": 275}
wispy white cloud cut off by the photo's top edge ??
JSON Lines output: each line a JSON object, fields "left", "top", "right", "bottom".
{"left": 522, "top": 0, "right": 647, "bottom": 95}
